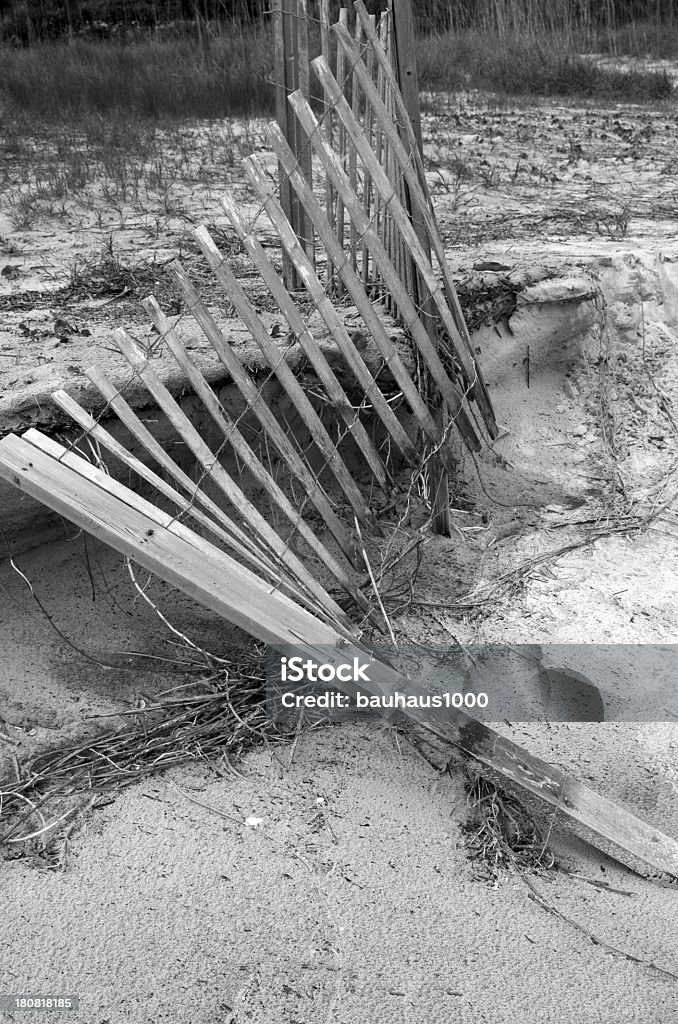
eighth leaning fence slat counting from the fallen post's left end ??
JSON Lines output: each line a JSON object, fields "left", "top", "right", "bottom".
{"left": 243, "top": 156, "right": 426, "bottom": 471}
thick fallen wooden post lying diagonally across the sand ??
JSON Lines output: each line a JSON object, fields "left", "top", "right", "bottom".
{"left": 0, "top": 430, "right": 678, "bottom": 879}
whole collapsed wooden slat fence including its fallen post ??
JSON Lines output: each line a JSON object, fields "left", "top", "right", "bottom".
{"left": 0, "top": 0, "right": 678, "bottom": 877}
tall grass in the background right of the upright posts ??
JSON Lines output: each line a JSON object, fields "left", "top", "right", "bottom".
{"left": 415, "top": 0, "right": 678, "bottom": 100}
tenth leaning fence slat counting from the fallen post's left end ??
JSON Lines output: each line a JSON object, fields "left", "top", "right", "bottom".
{"left": 290, "top": 87, "right": 481, "bottom": 452}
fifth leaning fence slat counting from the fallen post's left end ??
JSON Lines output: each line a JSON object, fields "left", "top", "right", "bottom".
{"left": 169, "top": 260, "right": 372, "bottom": 540}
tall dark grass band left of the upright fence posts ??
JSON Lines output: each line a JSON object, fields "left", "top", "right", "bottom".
{"left": 0, "top": 25, "right": 273, "bottom": 119}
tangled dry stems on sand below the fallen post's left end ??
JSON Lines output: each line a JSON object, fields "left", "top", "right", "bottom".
{"left": 0, "top": 646, "right": 277, "bottom": 868}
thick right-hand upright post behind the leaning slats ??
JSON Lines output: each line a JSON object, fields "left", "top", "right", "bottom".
{"left": 392, "top": 0, "right": 450, "bottom": 537}
